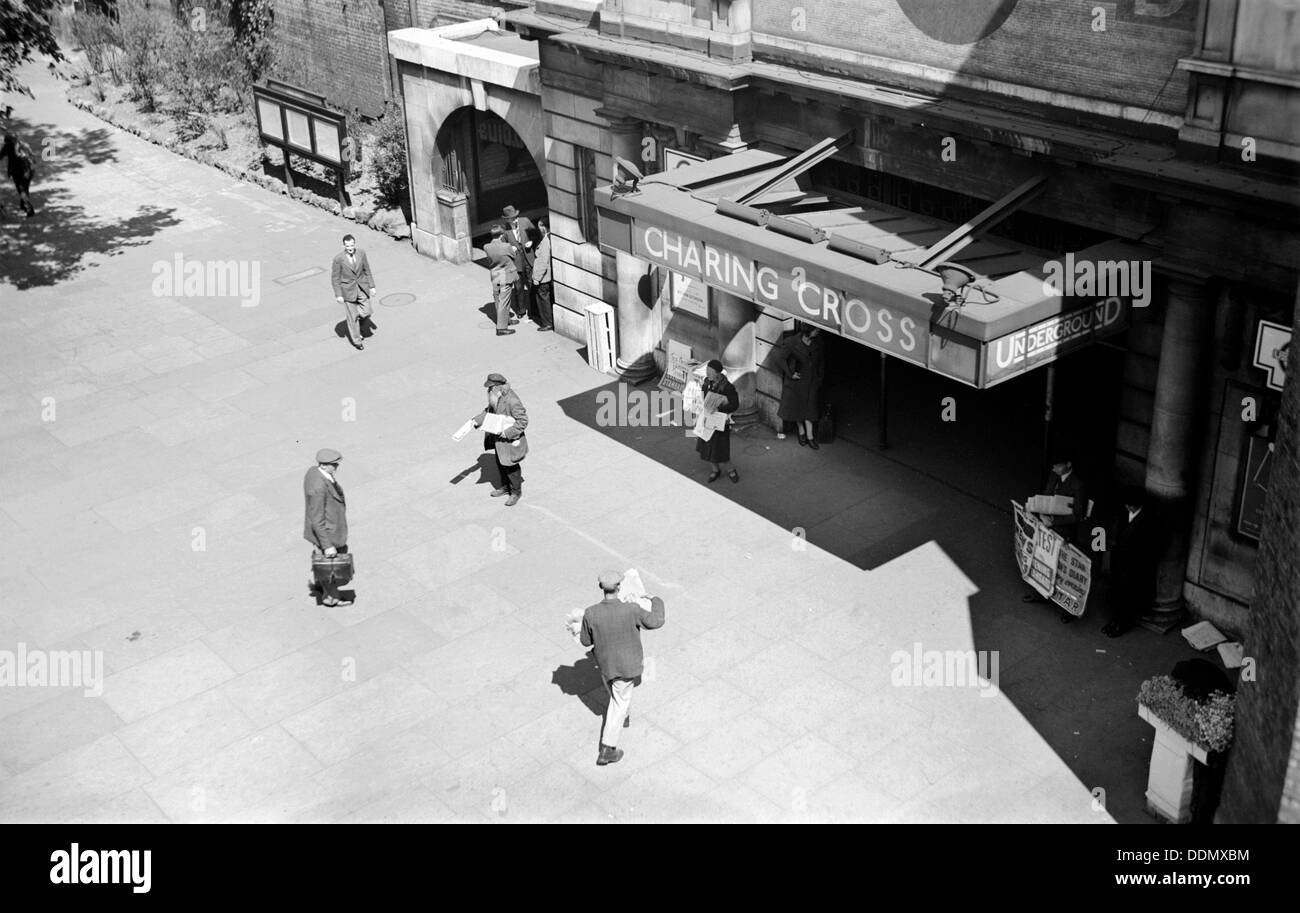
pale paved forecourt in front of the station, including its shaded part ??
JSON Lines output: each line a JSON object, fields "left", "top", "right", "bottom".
{"left": 0, "top": 60, "right": 1188, "bottom": 823}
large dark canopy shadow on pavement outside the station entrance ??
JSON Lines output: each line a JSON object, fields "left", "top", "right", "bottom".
{"left": 559, "top": 382, "right": 1196, "bottom": 823}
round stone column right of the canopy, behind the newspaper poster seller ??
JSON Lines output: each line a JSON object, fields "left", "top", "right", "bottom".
{"left": 1143, "top": 267, "right": 1214, "bottom": 632}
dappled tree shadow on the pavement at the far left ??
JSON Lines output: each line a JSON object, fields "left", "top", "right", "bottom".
{"left": 0, "top": 117, "right": 179, "bottom": 289}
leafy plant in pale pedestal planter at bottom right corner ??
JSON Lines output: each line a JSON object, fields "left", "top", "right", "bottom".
{"left": 1138, "top": 675, "right": 1236, "bottom": 825}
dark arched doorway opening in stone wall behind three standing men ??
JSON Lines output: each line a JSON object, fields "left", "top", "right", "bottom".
{"left": 433, "top": 107, "right": 547, "bottom": 245}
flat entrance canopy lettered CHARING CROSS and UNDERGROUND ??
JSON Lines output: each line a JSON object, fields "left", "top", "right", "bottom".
{"left": 595, "top": 138, "right": 1152, "bottom": 388}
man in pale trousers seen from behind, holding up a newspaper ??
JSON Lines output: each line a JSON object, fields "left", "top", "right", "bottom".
{"left": 580, "top": 571, "right": 664, "bottom": 767}
